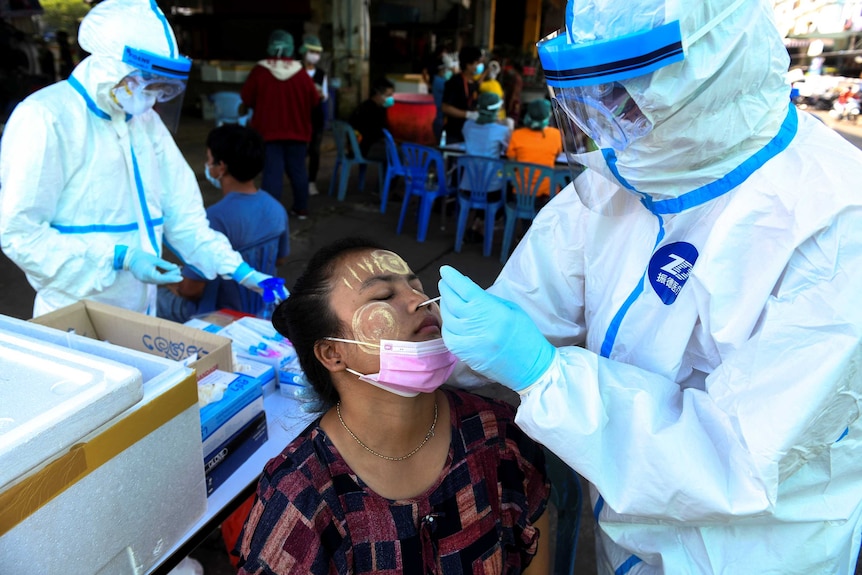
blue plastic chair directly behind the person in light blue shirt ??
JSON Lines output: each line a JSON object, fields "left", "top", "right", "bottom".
{"left": 455, "top": 156, "right": 506, "bottom": 257}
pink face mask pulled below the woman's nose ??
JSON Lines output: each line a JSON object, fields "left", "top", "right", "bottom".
{"left": 326, "top": 337, "right": 457, "bottom": 397}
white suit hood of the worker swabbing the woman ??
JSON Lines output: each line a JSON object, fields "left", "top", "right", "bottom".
{"left": 552, "top": 0, "right": 789, "bottom": 199}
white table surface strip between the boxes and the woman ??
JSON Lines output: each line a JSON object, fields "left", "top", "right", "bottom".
{"left": 148, "top": 383, "right": 317, "bottom": 574}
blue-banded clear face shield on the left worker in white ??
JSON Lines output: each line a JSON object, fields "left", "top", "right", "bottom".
{"left": 117, "top": 46, "right": 191, "bottom": 133}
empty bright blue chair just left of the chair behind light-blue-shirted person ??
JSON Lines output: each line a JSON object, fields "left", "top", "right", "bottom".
{"left": 397, "top": 143, "right": 452, "bottom": 242}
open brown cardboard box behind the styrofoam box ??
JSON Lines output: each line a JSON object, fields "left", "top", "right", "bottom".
{"left": 30, "top": 300, "right": 233, "bottom": 381}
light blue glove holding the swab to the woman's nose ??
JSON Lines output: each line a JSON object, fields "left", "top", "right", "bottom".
{"left": 438, "top": 266, "right": 556, "bottom": 391}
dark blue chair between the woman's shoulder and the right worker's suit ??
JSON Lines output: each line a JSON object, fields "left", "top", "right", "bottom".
{"left": 543, "top": 448, "right": 583, "bottom": 575}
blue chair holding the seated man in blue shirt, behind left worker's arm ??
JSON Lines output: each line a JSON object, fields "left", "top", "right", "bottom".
{"left": 196, "top": 234, "right": 281, "bottom": 315}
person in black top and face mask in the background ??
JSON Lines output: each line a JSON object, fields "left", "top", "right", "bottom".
{"left": 442, "top": 46, "right": 485, "bottom": 143}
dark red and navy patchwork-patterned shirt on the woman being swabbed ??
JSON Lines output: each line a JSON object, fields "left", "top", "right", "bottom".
{"left": 237, "top": 390, "right": 550, "bottom": 575}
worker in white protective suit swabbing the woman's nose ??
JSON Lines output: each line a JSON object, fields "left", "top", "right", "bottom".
{"left": 440, "top": 0, "right": 862, "bottom": 575}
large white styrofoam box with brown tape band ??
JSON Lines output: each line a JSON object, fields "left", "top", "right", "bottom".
{"left": 0, "top": 315, "right": 206, "bottom": 575}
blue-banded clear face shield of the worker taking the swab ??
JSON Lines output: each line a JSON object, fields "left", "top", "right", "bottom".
{"left": 538, "top": 22, "right": 683, "bottom": 214}
